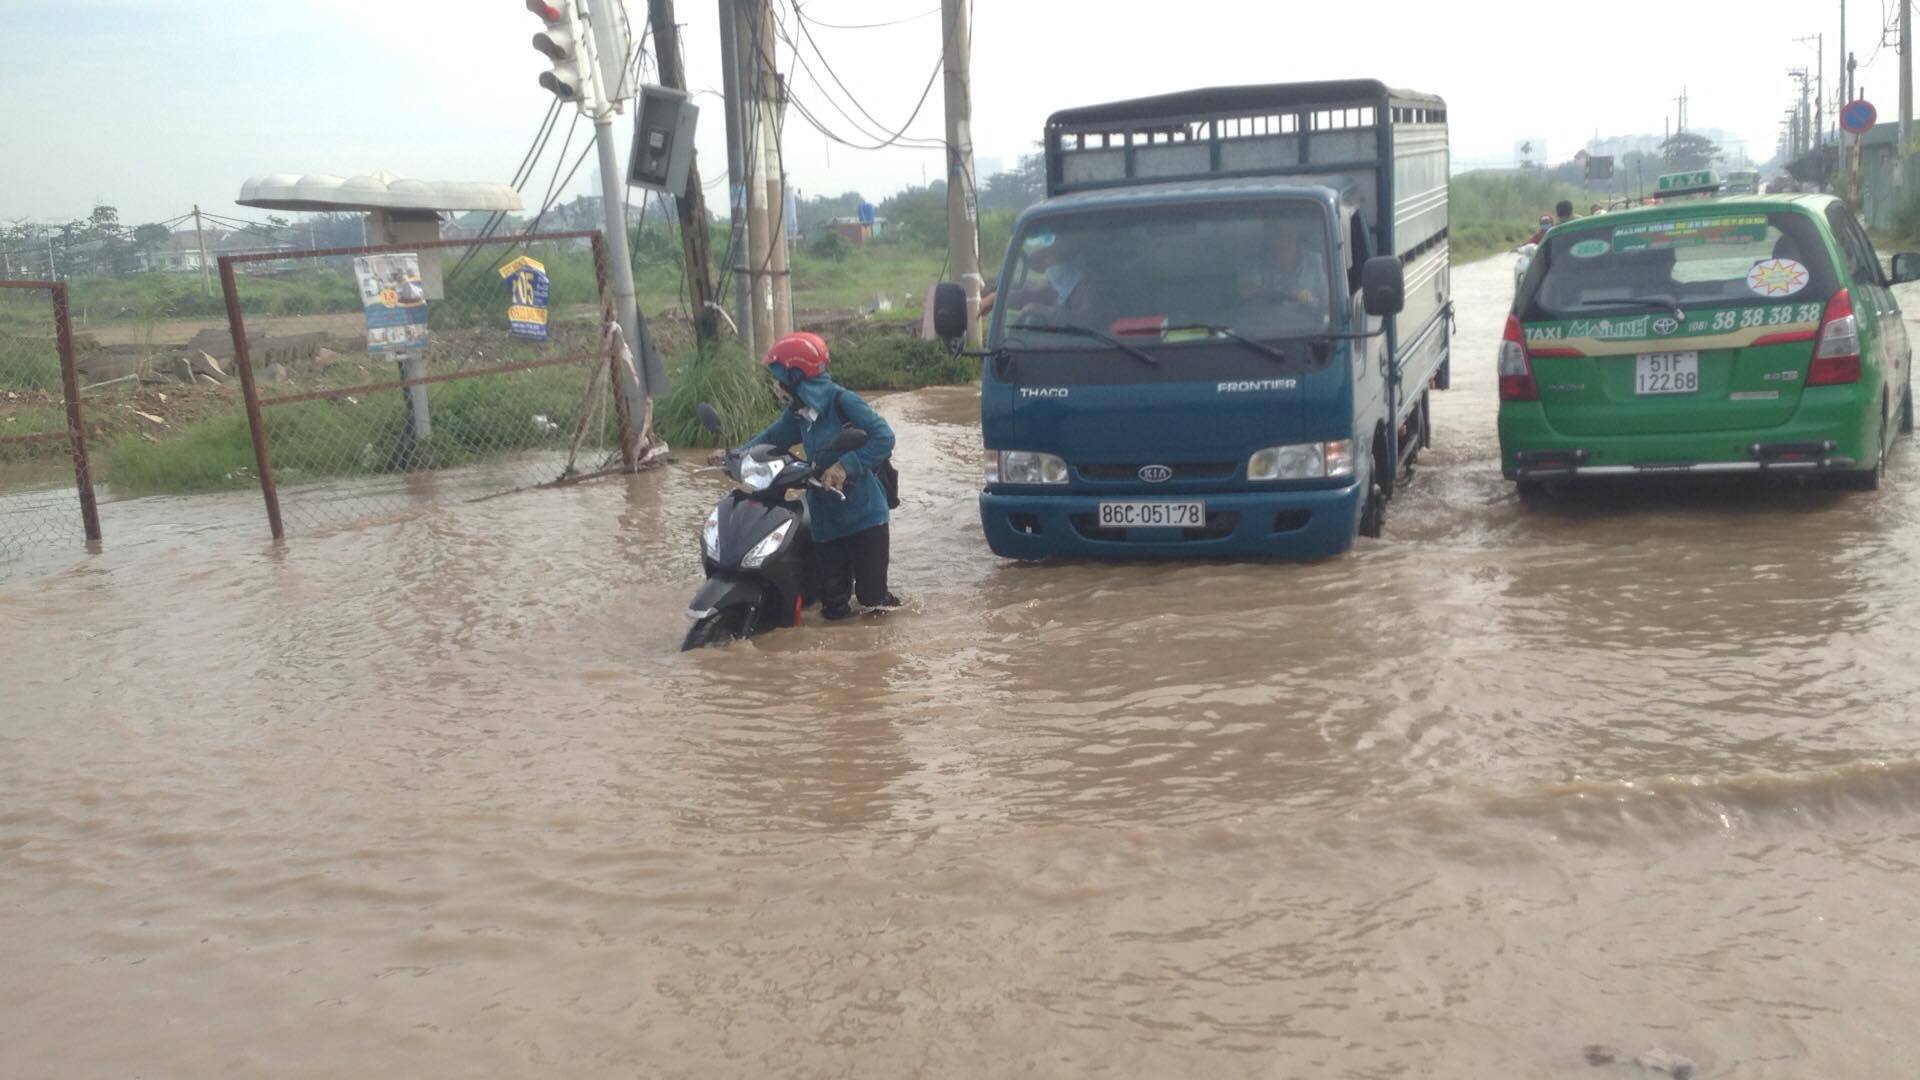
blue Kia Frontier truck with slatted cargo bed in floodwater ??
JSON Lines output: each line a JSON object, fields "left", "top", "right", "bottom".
{"left": 935, "top": 81, "right": 1452, "bottom": 559}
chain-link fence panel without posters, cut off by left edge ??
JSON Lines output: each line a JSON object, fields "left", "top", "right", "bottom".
{"left": 0, "top": 281, "right": 100, "bottom": 565}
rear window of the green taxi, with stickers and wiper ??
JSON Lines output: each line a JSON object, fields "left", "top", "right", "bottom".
{"left": 1521, "top": 211, "right": 1839, "bottom": 321}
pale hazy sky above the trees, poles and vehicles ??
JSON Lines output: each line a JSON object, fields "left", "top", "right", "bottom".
{"left": 0, "top": 0, "right": 1899, "bottom": 223}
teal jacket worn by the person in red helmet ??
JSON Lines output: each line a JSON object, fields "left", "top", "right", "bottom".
{"left": 741, "top": 367, "right": 893, "bottom": 542}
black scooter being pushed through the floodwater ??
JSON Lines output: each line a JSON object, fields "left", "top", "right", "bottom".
{"left": 680, "top": 402, "right": 866, "bottom": 651}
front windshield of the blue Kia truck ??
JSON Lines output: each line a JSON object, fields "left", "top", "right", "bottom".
{"left": 995, "top": 200, "right": 1332, "bottom": 350}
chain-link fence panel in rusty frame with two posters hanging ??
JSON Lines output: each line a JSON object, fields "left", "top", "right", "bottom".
{"left": 221, "top": 233, "right": 630, "bottom": 536}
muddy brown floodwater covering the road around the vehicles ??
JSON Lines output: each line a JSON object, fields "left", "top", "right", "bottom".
{"left": 0, "top": 259, "right": 1920, "bottom": 1078}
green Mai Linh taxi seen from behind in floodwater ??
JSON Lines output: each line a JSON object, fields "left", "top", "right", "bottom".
{"left": 1500, "top": 175, "right": 1920, "bottom": 496}
